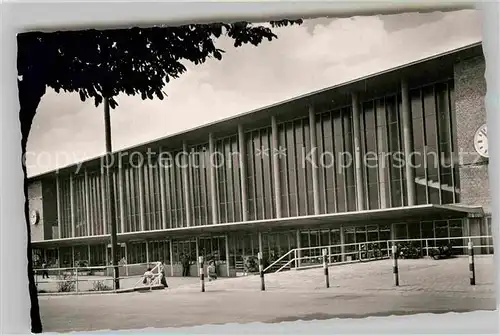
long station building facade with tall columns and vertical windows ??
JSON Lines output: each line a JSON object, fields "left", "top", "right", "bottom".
{"left": 28, "top": 44, "right": 492, "bottom": 276}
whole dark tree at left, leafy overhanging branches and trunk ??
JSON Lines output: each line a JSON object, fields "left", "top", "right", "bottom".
{"left": 17, "top": 20, "right": 302, "bottom": 333}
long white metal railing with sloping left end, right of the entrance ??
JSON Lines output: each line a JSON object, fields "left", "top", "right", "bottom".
{"left": 264, "top": 235, "right": 493, "bottom": 273}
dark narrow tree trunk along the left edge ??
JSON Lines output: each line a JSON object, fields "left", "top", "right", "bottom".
{"left": 18, "top": 78, "right": 45, "bottom": 334}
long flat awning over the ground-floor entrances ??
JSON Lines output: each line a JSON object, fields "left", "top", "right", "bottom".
{"left": 32, "top": 205, "right": 484, "bottom": 247}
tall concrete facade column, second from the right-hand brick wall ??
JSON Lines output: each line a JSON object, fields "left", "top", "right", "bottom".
{"left": 352, "top": 93, "right": 365, "bottom": 211}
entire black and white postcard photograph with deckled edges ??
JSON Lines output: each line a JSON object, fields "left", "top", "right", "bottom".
{"left": 17, "top": 5, "right": 498, "bottom": 333}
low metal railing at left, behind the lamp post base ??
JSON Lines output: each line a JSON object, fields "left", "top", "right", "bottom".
{"left": 33, "top": 262, "right": 162, "bottom": 294}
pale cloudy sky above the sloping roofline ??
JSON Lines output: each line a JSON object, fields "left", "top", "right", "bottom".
{"left": 26, "top": 10, "right": 482, "bottom": 176}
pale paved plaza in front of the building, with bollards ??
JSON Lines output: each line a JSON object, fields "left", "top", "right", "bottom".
{"left": 39, "top": 256, "right": 496, "bottom": 332}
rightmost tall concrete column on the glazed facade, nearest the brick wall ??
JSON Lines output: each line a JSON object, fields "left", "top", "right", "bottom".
{"left": 401, "top": 80, "right": 417, "bottom": 206}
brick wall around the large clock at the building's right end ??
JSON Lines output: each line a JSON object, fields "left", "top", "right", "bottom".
{"left": 455, "top": 53, "right": 491, "bottom": 213}
